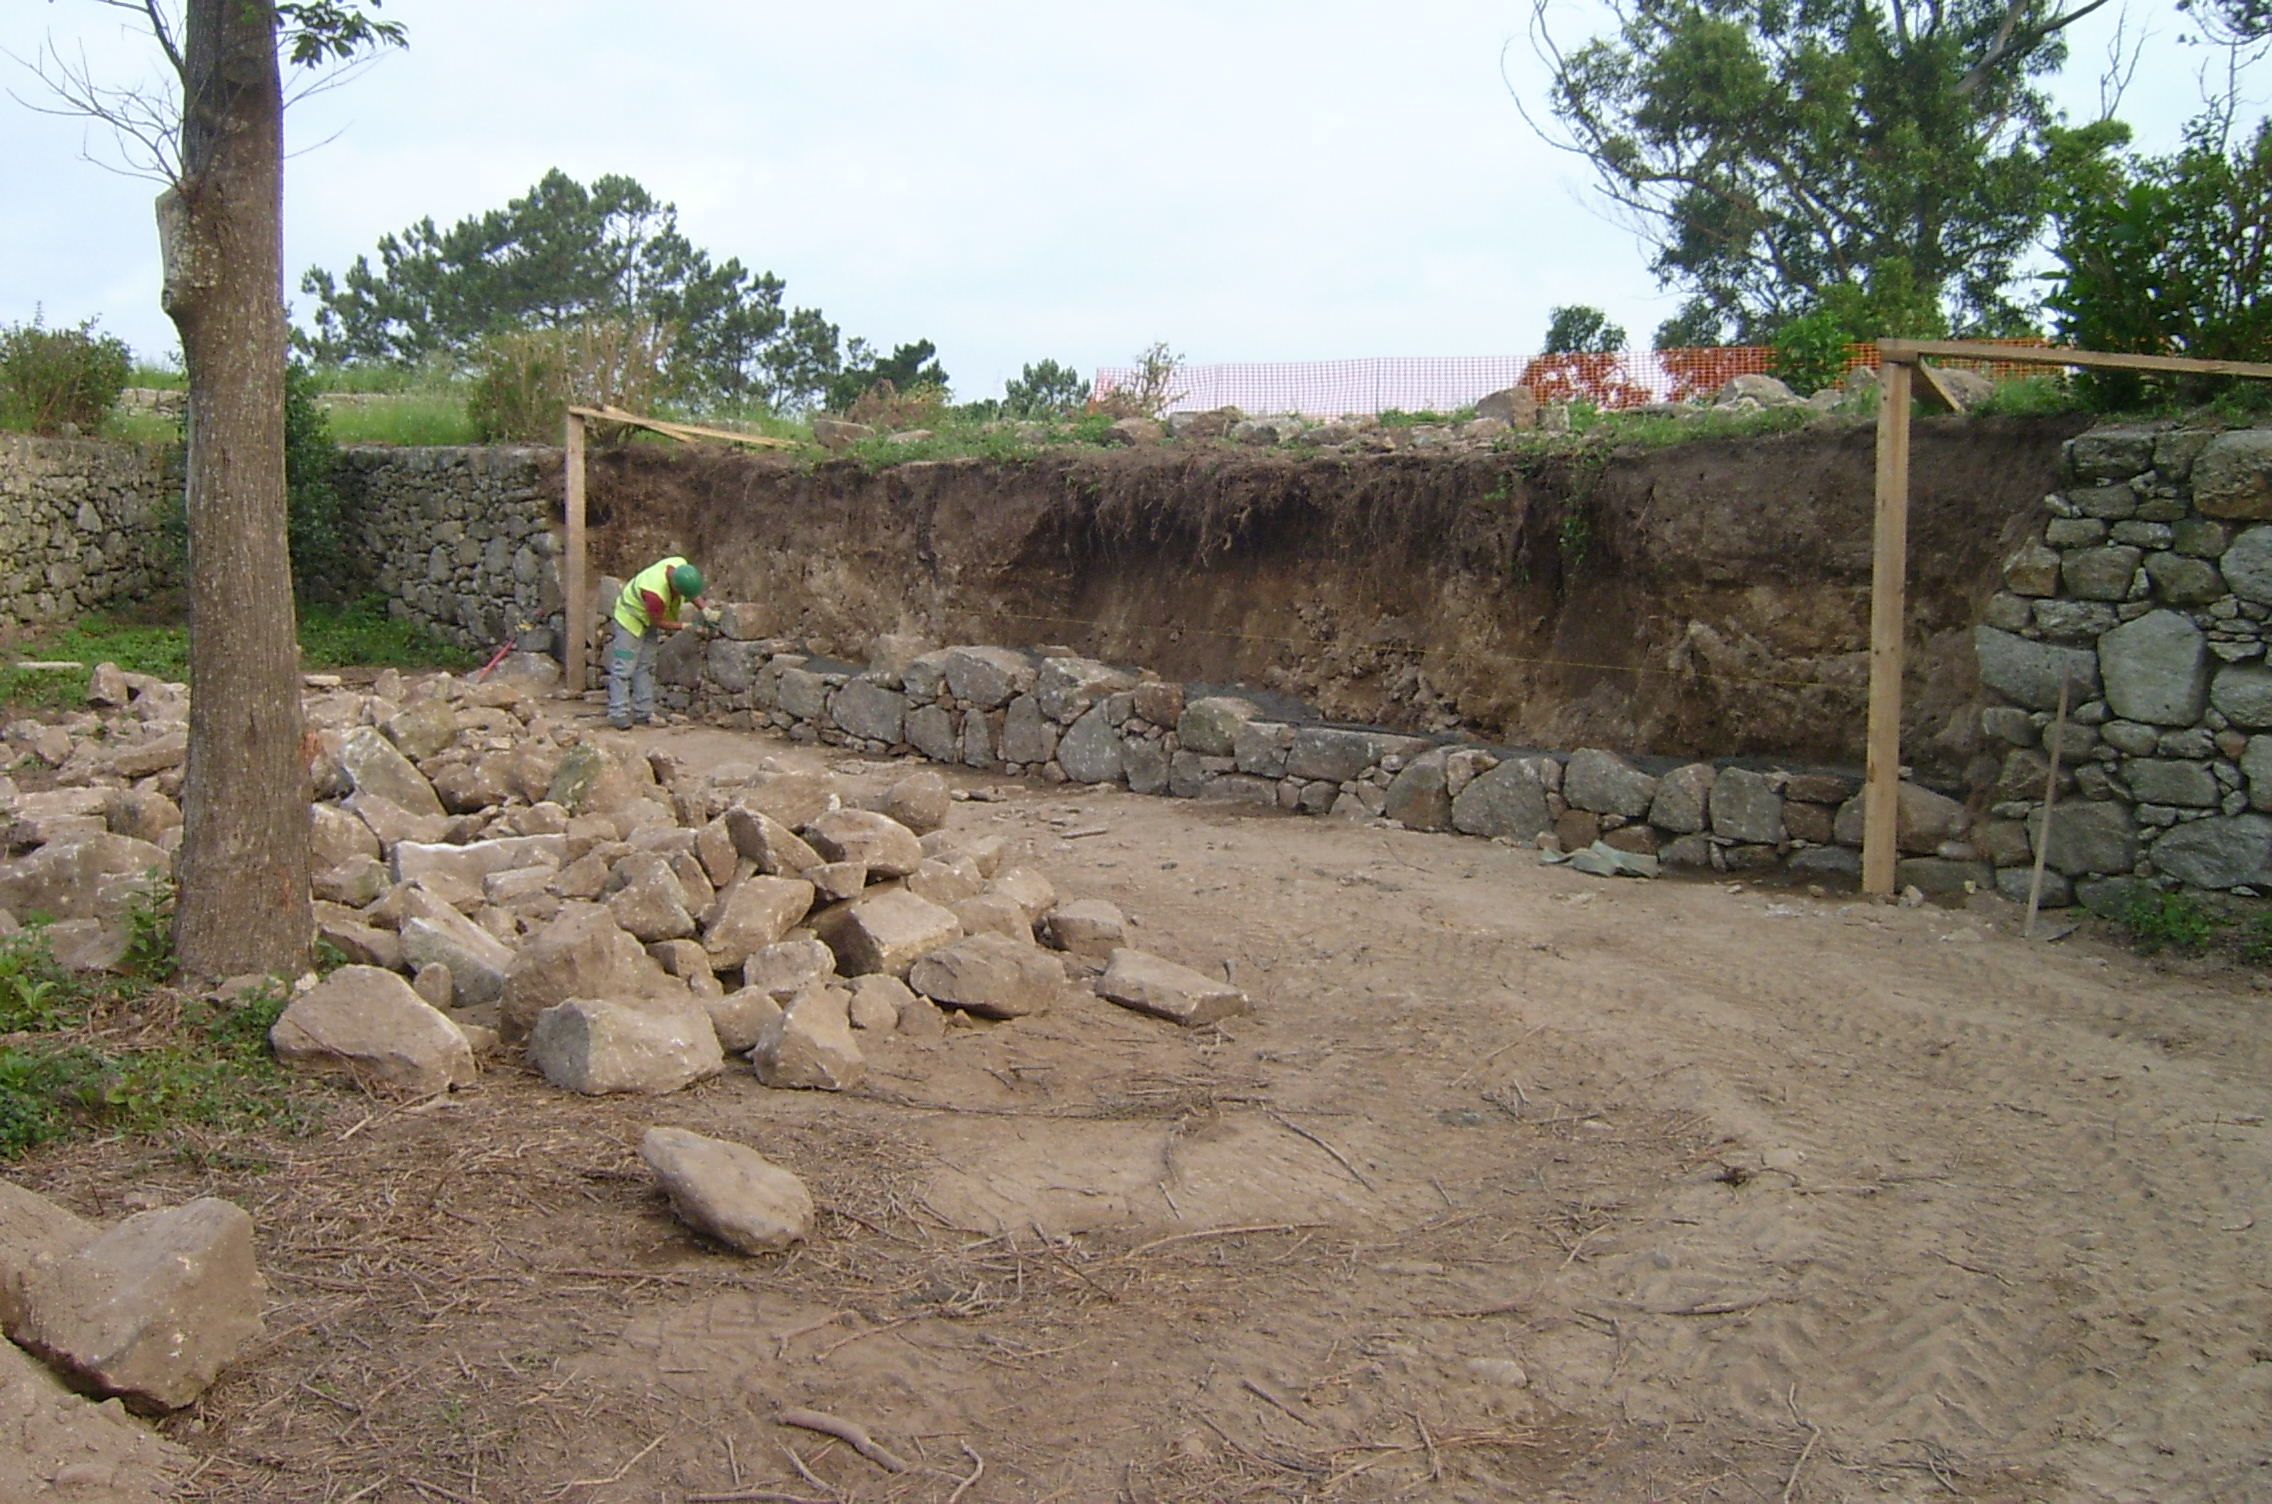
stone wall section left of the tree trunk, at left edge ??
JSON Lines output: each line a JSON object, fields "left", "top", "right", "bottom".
{"left": 0, "top": 434, "right": 182, "bottom": 627}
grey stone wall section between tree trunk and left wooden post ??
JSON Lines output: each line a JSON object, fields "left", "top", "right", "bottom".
{"left": 341, "top": 448, "right": 561, "bottom": 652}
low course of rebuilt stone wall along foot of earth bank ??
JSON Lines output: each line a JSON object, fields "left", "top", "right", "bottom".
{"left": 657, "top": 607, "right": 1993, "bottom": 893}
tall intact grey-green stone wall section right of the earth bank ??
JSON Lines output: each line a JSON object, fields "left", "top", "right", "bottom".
{"left": 1974, "top": 425, "right": 2272, "bottom": 906}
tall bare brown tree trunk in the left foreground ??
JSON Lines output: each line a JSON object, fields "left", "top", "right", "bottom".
{"left": 157, "top": 0, "right": 314, "bottom": 977}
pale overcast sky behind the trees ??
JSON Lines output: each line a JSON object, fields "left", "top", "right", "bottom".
{"left": 0, "top": 0, "right": 2235, "bottom": 398}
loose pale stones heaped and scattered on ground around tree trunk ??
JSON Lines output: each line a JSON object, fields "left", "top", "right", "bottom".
{"left": 0, "top": 659, "right": 1247, "bottom": 1435}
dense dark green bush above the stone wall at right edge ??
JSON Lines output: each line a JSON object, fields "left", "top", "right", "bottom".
{"left": 2045, "top": 109, "right": 2272, "bottom": 407}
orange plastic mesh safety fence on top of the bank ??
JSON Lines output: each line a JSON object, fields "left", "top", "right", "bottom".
{"left": 1095, "top": 339, "right": 2049, "bottom": 418}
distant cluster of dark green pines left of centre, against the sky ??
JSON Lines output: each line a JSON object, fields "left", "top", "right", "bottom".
{"left": 295, "top": 168, "right": 836, "bottom": 404}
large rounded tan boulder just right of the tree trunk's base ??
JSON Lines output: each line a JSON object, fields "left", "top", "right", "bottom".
{"left": 268, "top": 966, "right": 475, "bottom": 1095}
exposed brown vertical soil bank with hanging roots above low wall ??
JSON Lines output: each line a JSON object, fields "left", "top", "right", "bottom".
{"left": 591, "top": 418, "right": 2081, "bottom": 779}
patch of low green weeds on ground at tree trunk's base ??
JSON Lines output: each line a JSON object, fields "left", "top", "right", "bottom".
{"left": 0, "top": 918, "right": 311, "bottom": 1161}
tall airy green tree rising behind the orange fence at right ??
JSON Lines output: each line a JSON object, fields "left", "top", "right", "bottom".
{"left": 1534, "top": 0, "right": 2108, "bottom": 348}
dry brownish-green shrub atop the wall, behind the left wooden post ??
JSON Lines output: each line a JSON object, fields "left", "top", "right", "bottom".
{"left": 466, "top": 318, "right": 675, "bottom": 443}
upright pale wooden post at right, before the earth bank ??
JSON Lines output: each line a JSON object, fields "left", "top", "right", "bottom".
{"left": 1861, "top": 359, "right": 1911, "bottom": 893}
